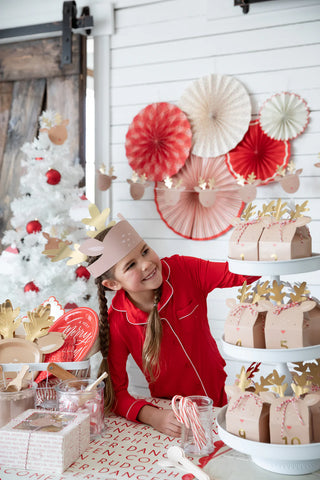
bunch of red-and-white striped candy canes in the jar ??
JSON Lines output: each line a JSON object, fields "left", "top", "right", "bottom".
{"left": 171, "top": 395, "right": 207, "bottom": 451}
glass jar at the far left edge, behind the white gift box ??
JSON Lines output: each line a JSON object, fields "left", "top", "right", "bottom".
{"left": 0, "top": 382, "right": 37, "bottom": 427}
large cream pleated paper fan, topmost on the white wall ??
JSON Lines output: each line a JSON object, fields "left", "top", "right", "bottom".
{"left": 178, "top": 75, "right": 251, "bottom": 157}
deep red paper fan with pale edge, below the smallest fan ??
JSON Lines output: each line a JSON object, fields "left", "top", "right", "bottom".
{"left": 226, "top": 120, "right": 290, "bottom": 185}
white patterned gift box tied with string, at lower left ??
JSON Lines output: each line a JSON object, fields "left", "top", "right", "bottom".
{"left": 0, "top": 409, "right": 90, "bottom": 473}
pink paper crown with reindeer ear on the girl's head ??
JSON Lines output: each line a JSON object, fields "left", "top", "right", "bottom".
{"left": 79, "top": 220, "right": 143, "bottom": 278}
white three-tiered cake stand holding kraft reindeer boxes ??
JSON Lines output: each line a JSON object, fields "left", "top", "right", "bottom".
{"left": 217, "top": 253, "right": 320, "bottom": 475}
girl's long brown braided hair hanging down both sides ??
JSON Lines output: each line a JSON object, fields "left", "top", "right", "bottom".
{"left": 88, "top": 227, "right": 162, "bottom": 414}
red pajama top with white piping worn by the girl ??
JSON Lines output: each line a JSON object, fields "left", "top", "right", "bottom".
{"left": 108, "top": 255, "right": 258, "bottom": 421}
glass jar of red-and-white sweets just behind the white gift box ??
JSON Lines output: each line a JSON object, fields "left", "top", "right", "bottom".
{"left": 55, "top": 378, "right": 105, "bottom": 440}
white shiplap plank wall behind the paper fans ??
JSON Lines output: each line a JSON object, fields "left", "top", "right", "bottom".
{"left": 102, "top": 0, "right": 320, "bottom": 394}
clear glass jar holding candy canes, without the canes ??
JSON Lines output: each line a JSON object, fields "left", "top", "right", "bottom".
{"left": 181, "top": 395, "right": 214, "bottom": 456}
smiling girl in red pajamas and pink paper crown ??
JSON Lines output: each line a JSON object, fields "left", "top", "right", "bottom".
{"left": 80, "top": 220, "right": 258, "bottom": 437}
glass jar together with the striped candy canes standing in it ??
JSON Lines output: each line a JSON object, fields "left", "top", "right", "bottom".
{"left": 172, "top": 395, "right": 213, "bottom": 456}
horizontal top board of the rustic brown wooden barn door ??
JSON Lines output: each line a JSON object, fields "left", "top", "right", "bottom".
{"left": 0, "top": 35, "right": 82, "bottom": 81}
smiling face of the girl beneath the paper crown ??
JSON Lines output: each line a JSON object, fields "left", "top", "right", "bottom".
{"left": 102, "top": 241, "right": 162, "bottom": 297}
